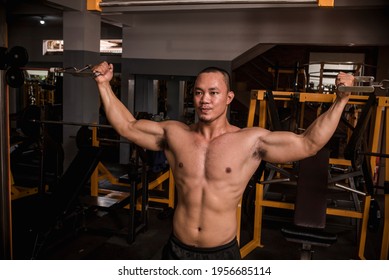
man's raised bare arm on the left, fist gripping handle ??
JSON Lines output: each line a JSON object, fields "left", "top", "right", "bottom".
{"left": 93, "top": 62, "right": 164, "bottom": 150}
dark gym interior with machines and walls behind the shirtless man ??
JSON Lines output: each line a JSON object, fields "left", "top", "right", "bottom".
{"left": 0, "top": 0, "right": 389, "bottom": 260}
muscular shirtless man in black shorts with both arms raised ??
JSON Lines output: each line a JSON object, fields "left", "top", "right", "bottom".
{"left": 93, "top": 62, "right": 354, "bottom": 259}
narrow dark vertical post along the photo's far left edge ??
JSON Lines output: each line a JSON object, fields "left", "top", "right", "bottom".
{"left": 0, "top": 70, "right": 12, "bottom": 260}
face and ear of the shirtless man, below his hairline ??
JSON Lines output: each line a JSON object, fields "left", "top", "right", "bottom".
{"left": 194, "top": 72, "right": 234, "bottom": 122}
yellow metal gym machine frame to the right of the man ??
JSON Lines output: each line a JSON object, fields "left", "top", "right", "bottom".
{"left": 237, "top": 90, "right": 389, "bottom": 259}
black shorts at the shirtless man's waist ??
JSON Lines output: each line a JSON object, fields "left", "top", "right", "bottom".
{"left": 162, "top": 235, "right": 241, "bottom": 260}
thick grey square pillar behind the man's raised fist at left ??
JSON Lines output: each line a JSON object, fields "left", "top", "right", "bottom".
{"left": 62, "top": 11, "right": 101, "bottom": 170}
